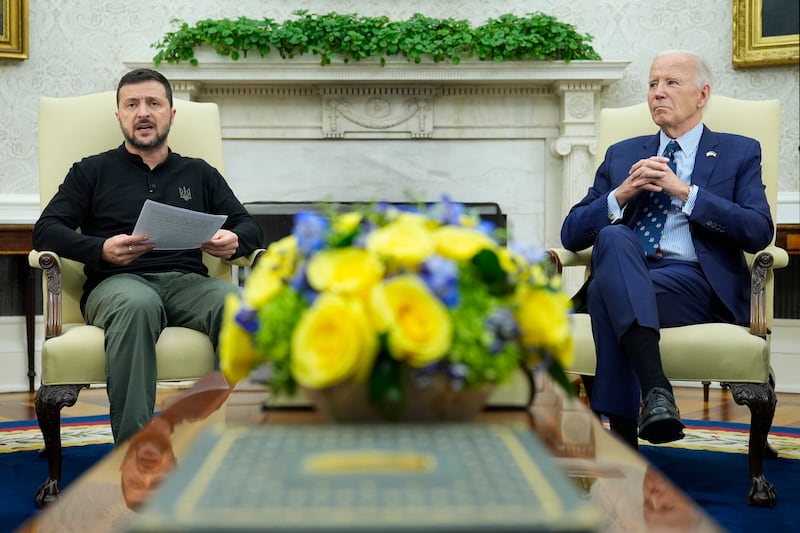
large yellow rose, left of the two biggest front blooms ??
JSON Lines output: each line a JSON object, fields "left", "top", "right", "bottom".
{"left": 291, "top": 293, "right": 378, "bottom": 389}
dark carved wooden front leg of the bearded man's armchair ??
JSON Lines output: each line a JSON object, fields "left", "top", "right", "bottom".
{"left": 33, "top": 385, "right": 88, "bottom": 507}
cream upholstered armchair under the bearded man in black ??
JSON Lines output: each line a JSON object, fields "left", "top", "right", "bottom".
{"left": 29, "top": 91, "right": 258, "bottom": 507}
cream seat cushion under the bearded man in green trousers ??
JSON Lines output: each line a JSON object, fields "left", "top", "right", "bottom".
{"left": 42, "top": 324, "right": 214, "bottom": 385}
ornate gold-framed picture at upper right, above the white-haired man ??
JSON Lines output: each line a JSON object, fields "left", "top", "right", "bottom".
{"left": 733, "top": 0, "right": 800, "bottom": 67}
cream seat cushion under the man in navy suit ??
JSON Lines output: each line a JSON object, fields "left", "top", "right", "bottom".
{"left": 569, "top": 313, "right": 769, "bottom": 383}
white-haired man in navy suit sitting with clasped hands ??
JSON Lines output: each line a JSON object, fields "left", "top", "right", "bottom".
{"left": 561, "top": 51, "right": 774, "bottom": 447}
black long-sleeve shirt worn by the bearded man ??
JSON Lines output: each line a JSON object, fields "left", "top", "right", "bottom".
{"left": 33, "top": 145, "right": 263, "bottom": 306}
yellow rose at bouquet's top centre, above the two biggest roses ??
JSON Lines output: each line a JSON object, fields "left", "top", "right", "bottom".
{"left": 307, "top": 248, "right": 383, "bottom": 298}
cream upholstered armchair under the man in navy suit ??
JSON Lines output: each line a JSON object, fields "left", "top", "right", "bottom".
{"left": 551, "top": 96, "right": 789, "bottom": 507}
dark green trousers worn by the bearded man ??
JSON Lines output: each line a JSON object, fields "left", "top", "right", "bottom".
{"left": 86, "top": 272, "right": 238, "bottom": 443}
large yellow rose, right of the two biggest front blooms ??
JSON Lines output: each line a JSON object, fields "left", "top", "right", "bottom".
{"left": 370, "top": 275, "right": 453, "bottom": 367}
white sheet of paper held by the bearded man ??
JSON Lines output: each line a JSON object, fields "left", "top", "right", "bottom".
{"left": 133, "top": 200, "right": 228, "bottom": 250}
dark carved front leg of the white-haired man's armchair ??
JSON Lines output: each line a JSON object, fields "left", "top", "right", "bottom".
{"left": 728, "top": 383, "right": 778, "bottom": 507}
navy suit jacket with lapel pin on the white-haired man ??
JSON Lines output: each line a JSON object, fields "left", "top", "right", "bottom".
{"left": 561, "top": 127, "right": 774, "bottom": 324}
